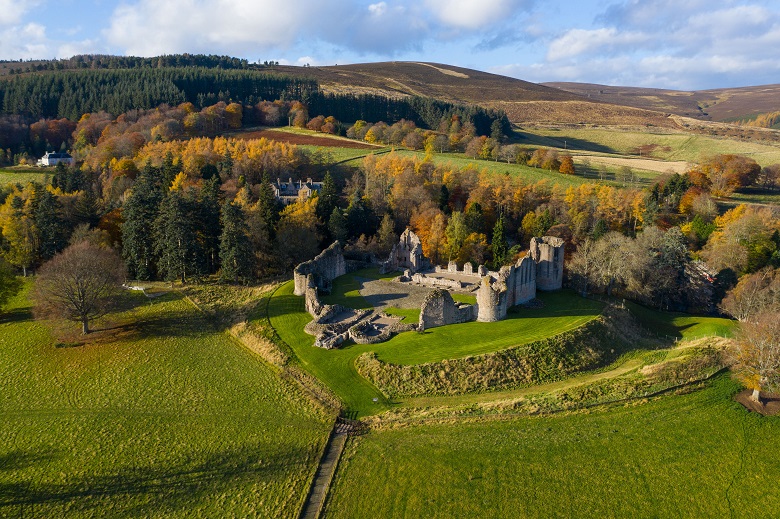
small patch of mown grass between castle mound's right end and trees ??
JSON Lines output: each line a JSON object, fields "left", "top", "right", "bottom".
{"left": 626, "top": 302, "right": 739, "bottom": 339}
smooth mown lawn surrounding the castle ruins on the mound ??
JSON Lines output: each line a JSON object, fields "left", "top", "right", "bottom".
{"left": 269, "top": 276, "right": 601, "bottom": 416}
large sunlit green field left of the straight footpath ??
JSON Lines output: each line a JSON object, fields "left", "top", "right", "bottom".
{"left": 0, "top": 282, "right": 329, "bottom": 518}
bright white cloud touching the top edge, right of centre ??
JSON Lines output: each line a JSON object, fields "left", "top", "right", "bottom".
{"left": 425, "top": 0, "right": 526, "bottom": 30}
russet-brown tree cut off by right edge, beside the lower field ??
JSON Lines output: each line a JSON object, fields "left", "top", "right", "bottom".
{"left": 733, "top": 312, "right": 780, "bottom": 402}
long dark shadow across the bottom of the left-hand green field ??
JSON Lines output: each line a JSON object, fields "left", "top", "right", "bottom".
{"left": 0, "top": 446, "right": 309, "bottom": 517}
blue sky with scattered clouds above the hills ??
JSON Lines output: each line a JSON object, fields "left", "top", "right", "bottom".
{"left": 0, "top": 0, "right": 780, "bottom": 90}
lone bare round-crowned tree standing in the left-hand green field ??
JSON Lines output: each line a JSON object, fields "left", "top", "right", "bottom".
{"left": 34, "top": 241, "right": 125, "bottom": 334}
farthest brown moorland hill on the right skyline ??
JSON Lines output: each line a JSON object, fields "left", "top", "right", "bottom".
{"left": 543, "top": 82, "right": 780, "bottom": 121}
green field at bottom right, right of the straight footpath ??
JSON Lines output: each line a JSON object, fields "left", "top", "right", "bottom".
{"left": 327, "top": 376, "right": 780, "bottom": 517}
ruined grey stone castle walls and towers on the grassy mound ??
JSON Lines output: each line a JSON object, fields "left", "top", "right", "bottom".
{"left": 294, "top": 229, "right": 565, "bottom": 348}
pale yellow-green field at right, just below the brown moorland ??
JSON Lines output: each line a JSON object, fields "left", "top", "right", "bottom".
{"left": 518, "top": 128, "right": 780, "bottom": 166}
